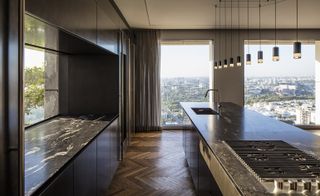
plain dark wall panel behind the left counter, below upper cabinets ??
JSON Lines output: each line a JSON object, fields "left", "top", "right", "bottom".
{"left": 60, "top": 55, "right": 119, "bottom": 114}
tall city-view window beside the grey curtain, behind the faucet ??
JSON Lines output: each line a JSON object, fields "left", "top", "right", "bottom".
{"left": 161, "top": 42, "right": 210, "bottom": 126}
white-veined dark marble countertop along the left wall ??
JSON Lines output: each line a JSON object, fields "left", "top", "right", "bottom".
{"left": 24, "top": 115, "right": 116, "bottom": 195}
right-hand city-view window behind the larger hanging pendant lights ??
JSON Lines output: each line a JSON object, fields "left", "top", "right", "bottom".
{"left": 245, "top": 43, "right": 320, "bottom": 125}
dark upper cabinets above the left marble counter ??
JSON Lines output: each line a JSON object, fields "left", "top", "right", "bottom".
{"left": 25, "top": 0, "right": 128, "bottom": 54}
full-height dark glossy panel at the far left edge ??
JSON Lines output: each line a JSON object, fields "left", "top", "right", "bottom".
{"left": 0, "top": 0, "right": 24, "bottom": 195}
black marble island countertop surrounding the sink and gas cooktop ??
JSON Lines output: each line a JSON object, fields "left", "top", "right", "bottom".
{"left": 181, "top": 102, "right": 320, "bottom": 195}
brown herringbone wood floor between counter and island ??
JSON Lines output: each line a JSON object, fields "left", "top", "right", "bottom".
{"left": 108, "top": 130, "right": 195, "bottom": 196}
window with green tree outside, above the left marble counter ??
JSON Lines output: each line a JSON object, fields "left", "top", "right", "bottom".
{"left": 24, "top": 47, "right": 59, "bottom": 126}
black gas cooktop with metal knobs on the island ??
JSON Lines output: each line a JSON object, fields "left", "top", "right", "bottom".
{"left": 226, "top": 140, "right": 320, "bottom": 194}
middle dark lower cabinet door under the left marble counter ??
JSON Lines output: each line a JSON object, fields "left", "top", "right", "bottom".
{"left": 74, "top": 141, "right": 97, "bottom": 196}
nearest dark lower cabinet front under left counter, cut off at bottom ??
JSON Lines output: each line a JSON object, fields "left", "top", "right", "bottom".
{"left": 40, "top": 164, "right": 74, "bottom": 196}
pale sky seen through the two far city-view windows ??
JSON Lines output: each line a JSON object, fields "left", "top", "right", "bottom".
{"left": 161, "top": 45, "right": 315, "bottom": 78}
